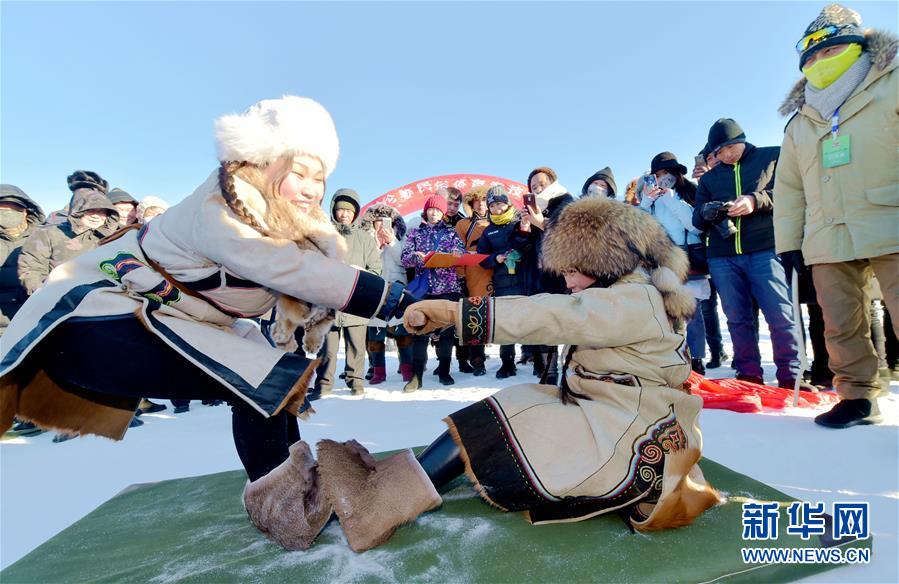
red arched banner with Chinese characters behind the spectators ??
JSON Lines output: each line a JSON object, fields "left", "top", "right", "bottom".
{"left": 362, "top": 174, "right": 527, "bottom": 217}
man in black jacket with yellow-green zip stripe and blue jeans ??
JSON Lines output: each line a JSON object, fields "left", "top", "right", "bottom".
{"left": 693, "top": 118, "right": 810, "bottom": 389}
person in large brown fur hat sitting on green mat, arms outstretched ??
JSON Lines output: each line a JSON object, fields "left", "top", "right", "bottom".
{"left": 310, "top": 198, "right": 719, "bottom": 547}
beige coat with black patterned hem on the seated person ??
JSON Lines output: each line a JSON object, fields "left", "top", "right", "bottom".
{"left": 447, "top": 269, "right": 719, "bottom": 530}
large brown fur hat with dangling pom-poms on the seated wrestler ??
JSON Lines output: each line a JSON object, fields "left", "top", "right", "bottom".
{"left": 542, "top": 197, "right": 696, "bottom": 321}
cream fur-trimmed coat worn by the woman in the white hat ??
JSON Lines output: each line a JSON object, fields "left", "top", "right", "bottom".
{"left": 0, "top": 172, "right": 387, "bottom": 439}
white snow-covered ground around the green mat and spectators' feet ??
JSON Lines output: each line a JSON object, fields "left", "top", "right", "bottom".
{"left": 0, "top": 326, "right": 899, "bottom": 582}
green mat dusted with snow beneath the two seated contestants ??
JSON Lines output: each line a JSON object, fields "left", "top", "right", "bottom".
{"left": 0, "top": 452, "right": 872, "bottom": 584}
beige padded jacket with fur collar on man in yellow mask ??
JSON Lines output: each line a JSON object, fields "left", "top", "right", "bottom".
{"left": 774, "top": 31, "right": 899, "bottom": 264}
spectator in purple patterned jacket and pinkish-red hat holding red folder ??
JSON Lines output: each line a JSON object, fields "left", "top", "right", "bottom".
{"left": 402, "top": 195, "right": 465, "bottom": 392}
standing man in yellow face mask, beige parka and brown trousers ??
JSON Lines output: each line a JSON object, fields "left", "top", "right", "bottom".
{"left": 774, "top": 4, "right": 899, "bottom": 428}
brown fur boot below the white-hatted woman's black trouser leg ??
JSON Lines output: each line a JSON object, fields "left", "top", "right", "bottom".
{"left": 243, "top": 440, "right": 331, "bottom": 550}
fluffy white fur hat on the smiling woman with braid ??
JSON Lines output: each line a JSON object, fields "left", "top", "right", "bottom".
{"left": 215, "top": 95, "right": 340, "bottom": 176}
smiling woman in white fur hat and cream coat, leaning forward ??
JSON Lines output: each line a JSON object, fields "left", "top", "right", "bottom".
{"left": 0, "top": 96, "right": 422, "bottom": 548}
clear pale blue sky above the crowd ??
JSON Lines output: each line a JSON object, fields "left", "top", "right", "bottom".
{"left": 0, "top": 1, "right": 897, "bottom": 211}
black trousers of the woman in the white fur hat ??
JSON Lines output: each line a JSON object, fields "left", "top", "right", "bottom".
{"left": 36, "top": 317, "right": 300, "bottom": 480}
